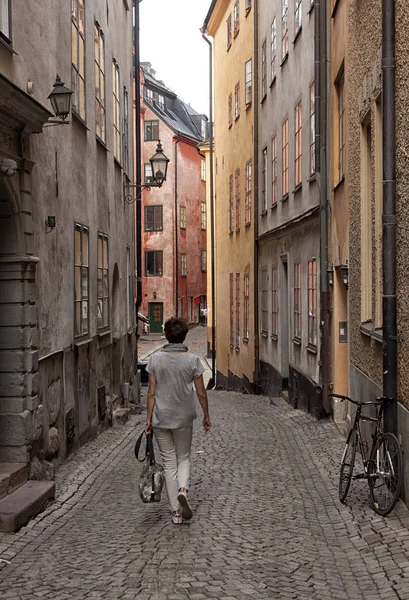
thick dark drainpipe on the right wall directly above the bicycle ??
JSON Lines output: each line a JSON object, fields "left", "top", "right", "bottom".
{"left": 382, "top": 0, "right": 398, "bottom": 434}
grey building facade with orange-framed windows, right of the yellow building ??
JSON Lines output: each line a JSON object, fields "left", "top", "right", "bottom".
{"left": 258, "top": 0, "right": 322, "bottom": 416}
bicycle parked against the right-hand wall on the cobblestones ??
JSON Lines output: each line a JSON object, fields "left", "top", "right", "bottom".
{"left": 329, "top": 394, "right": 403, "bottom": 517}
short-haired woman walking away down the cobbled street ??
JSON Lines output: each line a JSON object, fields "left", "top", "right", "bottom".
{"left": 145, "top": 317, "right": 211, "bottom": 525}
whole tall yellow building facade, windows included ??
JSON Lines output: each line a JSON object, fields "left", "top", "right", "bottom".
{"left": 204, "top": 0, "right": 258, "bottom": 391}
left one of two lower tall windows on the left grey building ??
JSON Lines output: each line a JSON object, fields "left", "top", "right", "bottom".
{"left": 74, "top": 224, "right": 89, "bottom": 337}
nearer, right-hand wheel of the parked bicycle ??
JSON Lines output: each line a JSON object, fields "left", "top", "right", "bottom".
{"left": 368, "top": 433, "right": 403, "bottom": 517}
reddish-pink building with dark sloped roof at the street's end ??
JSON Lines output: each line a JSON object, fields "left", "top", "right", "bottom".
{"left": 141, "top": 63, "right": 208, "bottom": 333}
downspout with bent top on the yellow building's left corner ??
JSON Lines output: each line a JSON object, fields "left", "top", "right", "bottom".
{"left": 200, "top": 26, "right": 216, "bottom": 389}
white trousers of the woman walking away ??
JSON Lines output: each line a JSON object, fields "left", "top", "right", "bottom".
{"left": 153, "top": 427, "right": 192, "bottom": 511}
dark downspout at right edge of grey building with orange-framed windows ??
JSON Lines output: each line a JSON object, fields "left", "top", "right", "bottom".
{"left": 314, "top": 0, "right": 330, "bottom": 414}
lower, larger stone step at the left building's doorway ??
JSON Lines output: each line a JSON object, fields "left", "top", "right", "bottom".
{"left": 0, "top": 481, "right": 55, "bottom": 533}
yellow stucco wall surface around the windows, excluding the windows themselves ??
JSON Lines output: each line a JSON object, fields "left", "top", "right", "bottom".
{"left": 207, "top": 0, "right": 255, "bottom": 381}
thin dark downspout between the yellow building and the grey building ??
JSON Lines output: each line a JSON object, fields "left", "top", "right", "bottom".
{"left": 252, "top": 0, "right": 260, "bottom": 394}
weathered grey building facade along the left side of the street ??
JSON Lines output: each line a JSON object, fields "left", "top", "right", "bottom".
{"left": 0, "top": 0, "right": 135, "bottom": 474}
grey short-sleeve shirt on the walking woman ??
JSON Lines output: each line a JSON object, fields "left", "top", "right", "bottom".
{"left": 146, "top": 351, "right": 204, "bottom": 429}
